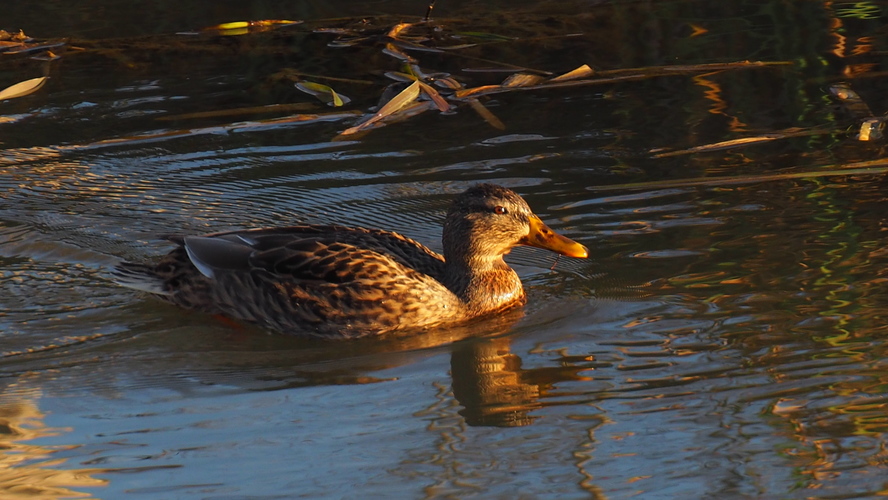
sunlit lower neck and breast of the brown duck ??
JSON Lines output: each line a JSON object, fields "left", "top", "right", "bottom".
{"left": 444, "top": 255, "right": 525, "bottom": 315}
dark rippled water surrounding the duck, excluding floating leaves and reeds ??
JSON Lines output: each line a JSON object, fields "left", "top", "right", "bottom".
{"left": 0, "top": 1, "right": 888, "bottom": 499}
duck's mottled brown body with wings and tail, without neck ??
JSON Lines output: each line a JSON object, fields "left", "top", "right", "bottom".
{"left": 116, "top": 225, "right": 464, "bottom": 337}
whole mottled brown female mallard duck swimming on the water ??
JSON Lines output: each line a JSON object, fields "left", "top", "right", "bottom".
{"left": 114, "top": 184, "right": 588, "bottom": 338}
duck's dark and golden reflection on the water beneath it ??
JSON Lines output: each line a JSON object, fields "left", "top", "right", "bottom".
{"left": 123, "top": 302, "right": 556, "bottom": 427}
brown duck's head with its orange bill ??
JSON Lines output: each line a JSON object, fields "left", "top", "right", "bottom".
{"left": 443, "top": 184, "right": 589, "bottom": 264}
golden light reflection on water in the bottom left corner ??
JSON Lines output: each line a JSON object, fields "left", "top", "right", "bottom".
{"left": 0, "top": 387, "right": 108, "bottom": 500}
